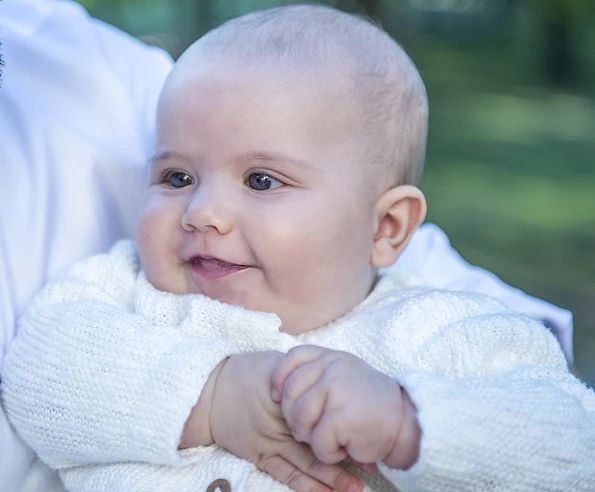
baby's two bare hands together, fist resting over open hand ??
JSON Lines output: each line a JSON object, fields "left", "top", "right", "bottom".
{"left": 181, "top": 345, "right": 421, "bottom": 492}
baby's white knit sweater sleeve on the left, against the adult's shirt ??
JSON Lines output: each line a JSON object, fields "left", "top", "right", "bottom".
{"left": 2, "top": 243, "right": 242, "bottom": 469}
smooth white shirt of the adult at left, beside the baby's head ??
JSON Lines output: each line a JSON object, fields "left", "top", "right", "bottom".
{"left": 0, "top": 0, "right": 171, "bottom": 492}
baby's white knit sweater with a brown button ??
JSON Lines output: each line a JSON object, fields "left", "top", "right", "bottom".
{"left": 3, "top": 241, "right": 595, "bottom": 492}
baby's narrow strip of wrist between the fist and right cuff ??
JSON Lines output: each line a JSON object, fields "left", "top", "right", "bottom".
{"left": 383, "top": 387, "right": 421, "bottom": 470}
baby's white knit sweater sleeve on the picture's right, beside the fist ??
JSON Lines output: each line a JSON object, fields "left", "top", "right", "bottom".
{"left": 380, "top": 304, "right": 595, "bottom": 492}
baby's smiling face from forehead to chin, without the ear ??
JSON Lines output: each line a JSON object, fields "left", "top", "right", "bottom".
{"left": 137, "top": 61, "right": 375, "bottom": 333}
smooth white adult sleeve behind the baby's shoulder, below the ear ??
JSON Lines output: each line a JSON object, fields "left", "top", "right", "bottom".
{"left": 389, "top": 224, "right": 573, "bottom": 362}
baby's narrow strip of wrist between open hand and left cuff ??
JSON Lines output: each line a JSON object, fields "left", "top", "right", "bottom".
{"left": 178, "top": 359, "right": 227, "bottom": 449}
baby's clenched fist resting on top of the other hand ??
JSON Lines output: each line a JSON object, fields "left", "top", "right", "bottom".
{"left": 272, "top": 345, "right": 421, "bottom": 469}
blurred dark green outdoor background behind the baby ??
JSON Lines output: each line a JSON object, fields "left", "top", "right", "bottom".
{"left": 81, "top": 0, "right": 595, "bottom": 383}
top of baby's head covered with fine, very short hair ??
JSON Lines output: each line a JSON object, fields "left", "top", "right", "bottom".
{"left": 160, "top": 6, "right": 427, "bottom": 182}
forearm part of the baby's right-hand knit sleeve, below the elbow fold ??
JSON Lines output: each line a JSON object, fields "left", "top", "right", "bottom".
{"left": 380, "top": 368, "right": 595, "bottom": 492}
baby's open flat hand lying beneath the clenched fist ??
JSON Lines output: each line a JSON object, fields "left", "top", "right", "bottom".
{"left": 210, "top": 352, "right": 363, "bottom": 492}
